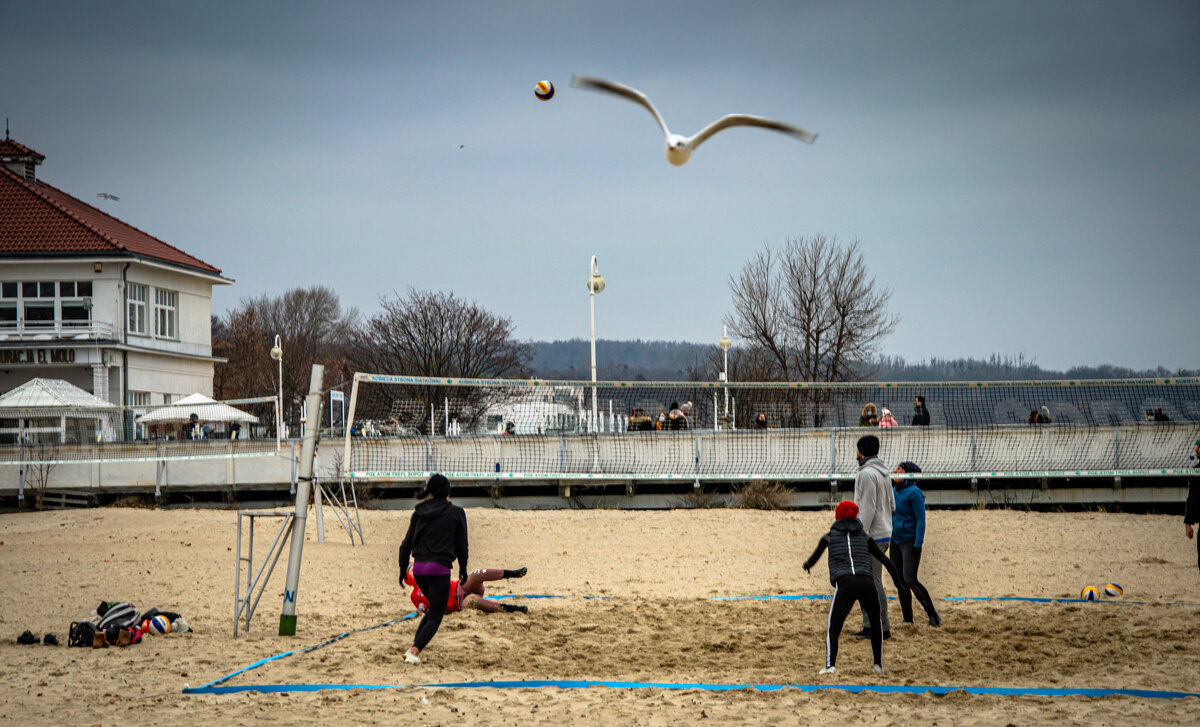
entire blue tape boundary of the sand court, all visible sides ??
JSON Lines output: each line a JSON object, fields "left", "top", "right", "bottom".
{"left": 182, "top": 594, "right": 1200, "bottom": 698}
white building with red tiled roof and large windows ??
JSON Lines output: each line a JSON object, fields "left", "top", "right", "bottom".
{"left": 0, "top": 139, "right": 233, "bottom": 407}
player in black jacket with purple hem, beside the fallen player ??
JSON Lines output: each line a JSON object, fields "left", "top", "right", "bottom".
{"left": 400, "top": 474, "right": 467, "bottom": 663}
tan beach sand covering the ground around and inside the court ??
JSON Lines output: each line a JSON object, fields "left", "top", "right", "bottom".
{"left": 0, "top": 509, "right": 1200, "bottom": 727}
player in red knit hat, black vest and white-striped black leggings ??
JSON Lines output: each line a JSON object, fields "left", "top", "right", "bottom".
{"left": 804, "top": 500, "right": 900, "bottom": 674}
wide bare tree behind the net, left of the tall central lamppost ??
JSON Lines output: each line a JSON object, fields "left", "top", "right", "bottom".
{"left": 348, "top": 288, "right": 533, "bottom": 432}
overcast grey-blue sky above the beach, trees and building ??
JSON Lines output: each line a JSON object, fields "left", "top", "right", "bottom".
{"left": 0, "top": 0, "right": 1200, "bottom": 368}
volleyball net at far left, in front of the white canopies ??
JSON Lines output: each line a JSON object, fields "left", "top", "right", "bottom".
{"left": 0, "top": 390, "right": 281, "bottom": 467}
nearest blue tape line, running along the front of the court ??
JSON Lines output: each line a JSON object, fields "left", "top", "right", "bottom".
{"left": 184, "top": 679, "right": 1200, "bottom": 699}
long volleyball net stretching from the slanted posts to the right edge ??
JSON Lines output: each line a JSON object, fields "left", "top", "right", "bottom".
{"left": 344, "top": 373, "right": 1200, "bottom": 481}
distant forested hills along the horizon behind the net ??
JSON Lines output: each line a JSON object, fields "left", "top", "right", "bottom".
{"left": 529, "top": 338, "right": 1200, "bottom": 381}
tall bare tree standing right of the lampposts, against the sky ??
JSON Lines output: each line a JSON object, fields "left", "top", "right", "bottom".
{"left": 725, "top": 235, "right": 899, "bottom": 426}
